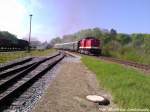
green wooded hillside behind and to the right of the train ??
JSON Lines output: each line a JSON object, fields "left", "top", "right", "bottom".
{"left": 50, "top": 28, "right": 150, "bottom": 64}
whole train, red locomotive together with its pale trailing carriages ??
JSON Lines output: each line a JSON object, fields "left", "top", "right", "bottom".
{"left": 54, "top": 37, "right": 101, "bottom": 55}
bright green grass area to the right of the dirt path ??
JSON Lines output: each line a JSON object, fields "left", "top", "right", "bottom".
{"left": 82, "top": 56, "right": 150, "bottom": 109}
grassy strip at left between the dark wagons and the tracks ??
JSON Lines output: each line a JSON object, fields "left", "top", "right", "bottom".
{"left": 0, "top": 49, "right": 55, "bottom": 63}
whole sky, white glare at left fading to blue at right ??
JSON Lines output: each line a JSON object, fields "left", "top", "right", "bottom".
{"left": 0, "top": 0, "right": 150, "bottom": 41}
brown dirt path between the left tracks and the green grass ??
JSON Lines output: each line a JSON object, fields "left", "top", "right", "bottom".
{"left": 33, "top": 56, "right": 114, "bottom": 112}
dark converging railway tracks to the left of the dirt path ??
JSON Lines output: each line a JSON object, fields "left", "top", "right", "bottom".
{"left": 0, "top": 53, "right": 65, "bottom": 111}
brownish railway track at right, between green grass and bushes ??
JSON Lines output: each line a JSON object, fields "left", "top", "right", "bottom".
{"left": 97, "top": 56, "right": 150, "bottom": 71}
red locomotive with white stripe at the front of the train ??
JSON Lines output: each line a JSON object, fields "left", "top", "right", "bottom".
{"left": 79, "top": 37, "right": 101, "bottom": 55}
